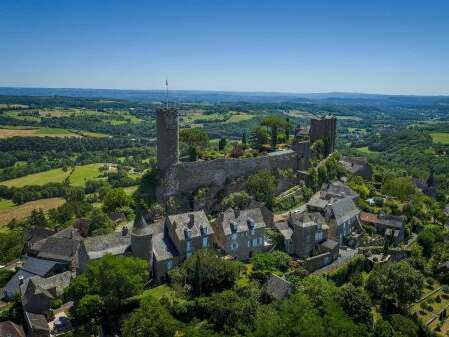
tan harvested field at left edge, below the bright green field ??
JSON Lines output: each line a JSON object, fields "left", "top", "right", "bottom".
{"left": 0, "top": 198, "right": 65, "bottom": 226}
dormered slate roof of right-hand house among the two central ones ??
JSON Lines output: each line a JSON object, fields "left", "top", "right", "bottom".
{"left": 220, "top": 208, "right": 266, "bottom": 235}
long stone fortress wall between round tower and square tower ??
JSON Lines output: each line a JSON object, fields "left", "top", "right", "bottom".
{"left": 163, "top": 150, "right": 298, "bottom": 196}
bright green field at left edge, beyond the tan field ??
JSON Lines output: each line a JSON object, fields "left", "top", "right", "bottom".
{"left": 0, "top": 164, "right": 102, "bottom": 187}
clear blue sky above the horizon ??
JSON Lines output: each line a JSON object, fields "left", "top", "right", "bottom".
{"left": 0, "top": 0, "right": 449, "bottom": 95}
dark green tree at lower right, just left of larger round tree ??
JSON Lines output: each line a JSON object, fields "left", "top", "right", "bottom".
{"left": 338, "top": 284, "right": 373, "bottom": 326}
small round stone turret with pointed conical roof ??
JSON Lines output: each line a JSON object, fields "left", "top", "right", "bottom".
{"left": 131, "top": 216, "right": 153, "bottom": 272}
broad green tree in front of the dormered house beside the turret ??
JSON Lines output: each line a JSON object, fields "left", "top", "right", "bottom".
{"left": 170, "top": 249, "right": 241, "bottom": 295}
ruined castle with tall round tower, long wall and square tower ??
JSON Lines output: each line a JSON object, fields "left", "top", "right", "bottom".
{"left": 156, "top": 108, "right": 336, "bottom": 201}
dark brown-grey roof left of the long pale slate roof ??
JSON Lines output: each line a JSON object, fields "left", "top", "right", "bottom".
{"left": 37, "top": 236, "right": 80, "bottom": 262}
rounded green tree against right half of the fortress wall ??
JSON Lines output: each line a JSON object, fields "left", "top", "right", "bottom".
{"left": 246, "top": 170, "right": 277, "bottom": 207}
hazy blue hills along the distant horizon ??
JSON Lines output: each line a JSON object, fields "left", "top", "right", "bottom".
{"left": 0, "top": 87, "right": 449, "bottom": 105}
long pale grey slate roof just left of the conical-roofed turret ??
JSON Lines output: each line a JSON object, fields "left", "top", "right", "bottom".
{"left": 84, "top": 231, "right": 131, "bottom": 260}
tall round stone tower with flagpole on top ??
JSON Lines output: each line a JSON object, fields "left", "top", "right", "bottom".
{"left": 156, "top": 108, "right": 179, "bottom": 171}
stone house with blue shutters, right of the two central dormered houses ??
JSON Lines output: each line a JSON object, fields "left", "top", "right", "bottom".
{"left": 214, "top": 208, "right": 266, "bottom": 260}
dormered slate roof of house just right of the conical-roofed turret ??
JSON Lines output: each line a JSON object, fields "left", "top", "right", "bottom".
{"left": 168, "top": 211, "right": 214, "bottom": 241}
